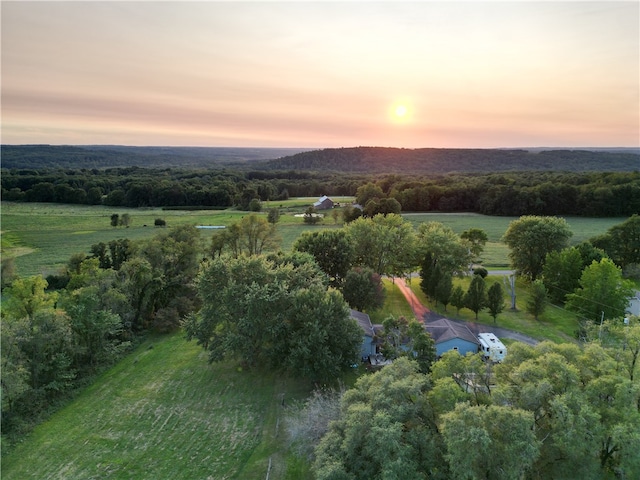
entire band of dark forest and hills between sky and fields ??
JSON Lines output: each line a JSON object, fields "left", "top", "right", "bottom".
{"left": 2, "top": 145, "right": 640, "bottom": 216}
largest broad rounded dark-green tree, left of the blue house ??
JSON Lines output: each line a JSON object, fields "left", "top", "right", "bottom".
{"left": 184, "top": 254, "right": 363, "bottom": 381}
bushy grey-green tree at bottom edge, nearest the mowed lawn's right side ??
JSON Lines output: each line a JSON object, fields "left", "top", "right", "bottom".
{"left": 314, "top": 358, "right": 447, "bottom": 480}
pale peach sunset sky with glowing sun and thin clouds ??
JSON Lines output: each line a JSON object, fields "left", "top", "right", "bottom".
{"left": 0, "top": 0, "right": 640, "bottom": 148}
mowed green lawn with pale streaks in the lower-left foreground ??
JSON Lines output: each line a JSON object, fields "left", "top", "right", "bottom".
{"left": 2, "top": 333, "right": 309, "bottom": 480}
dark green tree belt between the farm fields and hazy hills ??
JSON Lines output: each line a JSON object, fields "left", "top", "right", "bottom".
{"left": 1, "top": 167, "right": 640, "bottom": 217}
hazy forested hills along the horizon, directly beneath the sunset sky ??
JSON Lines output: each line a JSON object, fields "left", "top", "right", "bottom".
{"left": 2, "top": 145, "right": 640, "bottom": 174}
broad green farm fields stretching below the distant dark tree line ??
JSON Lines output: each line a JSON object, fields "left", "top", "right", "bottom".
{"left": 1, "top": 201, "right": 625, "bottom": 276}
